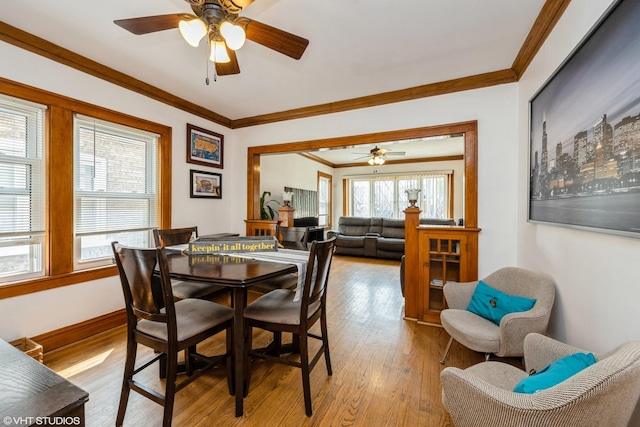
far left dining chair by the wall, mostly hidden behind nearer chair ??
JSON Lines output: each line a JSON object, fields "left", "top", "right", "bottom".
{"left": 153, "top": 227, "right": 229, "bottom": 299}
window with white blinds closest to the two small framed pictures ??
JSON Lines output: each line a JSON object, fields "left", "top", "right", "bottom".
{"left": 74, "top": 116, "right": 159, "bottom": 269}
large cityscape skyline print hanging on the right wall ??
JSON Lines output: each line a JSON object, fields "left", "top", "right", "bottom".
{"left": 529, "top": 0, "right": 640, "bottom": 238}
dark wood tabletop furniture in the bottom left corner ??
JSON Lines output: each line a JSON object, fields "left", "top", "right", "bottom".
{"left": 0, "top": 340, "right": 89, "bottom": 427}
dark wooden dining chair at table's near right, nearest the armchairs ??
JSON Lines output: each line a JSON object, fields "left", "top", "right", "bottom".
{"left": 244, "top": 237, "right": 335, "bottom": 416}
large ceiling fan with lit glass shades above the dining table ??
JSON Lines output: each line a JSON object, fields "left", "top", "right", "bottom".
{"left": 113, "top": 0, "right": 309, "bottom": 77}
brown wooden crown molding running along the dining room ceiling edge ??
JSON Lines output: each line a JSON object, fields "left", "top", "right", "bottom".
{"left": 0, "top": 0, "right": 571, "bottom": 129}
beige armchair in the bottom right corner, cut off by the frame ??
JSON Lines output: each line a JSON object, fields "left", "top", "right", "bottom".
{"left": 440, "top": 334, "right": 640, "bottom": 427}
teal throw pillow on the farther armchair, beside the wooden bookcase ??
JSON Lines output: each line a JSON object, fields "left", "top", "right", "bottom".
{"left": 467, "top": 280, "right": 536, "bottom": 325}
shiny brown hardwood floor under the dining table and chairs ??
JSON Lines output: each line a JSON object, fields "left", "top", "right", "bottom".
{"left": 45, "top": 256, "right": 517, "bottom": 427}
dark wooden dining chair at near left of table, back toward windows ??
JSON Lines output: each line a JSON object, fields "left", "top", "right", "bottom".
{"left": 111, "top": 242, "right": 234, "bottom": 427}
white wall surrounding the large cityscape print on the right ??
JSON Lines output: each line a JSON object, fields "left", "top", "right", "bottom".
{"left": 517, "top": 0, "right": 640, "bottom": 351}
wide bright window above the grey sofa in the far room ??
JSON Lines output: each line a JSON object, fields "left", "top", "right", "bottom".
{"left": 348, "top": 171, "right": 453, "bottom": 219}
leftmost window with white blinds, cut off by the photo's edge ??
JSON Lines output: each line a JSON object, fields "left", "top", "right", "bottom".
{"left": 0, "top": 96, "right": 46, "bottom": 283}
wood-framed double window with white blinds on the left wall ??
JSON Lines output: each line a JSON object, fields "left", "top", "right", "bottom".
{"left": 0, "top": 80, "right": 171, "bottom": 299}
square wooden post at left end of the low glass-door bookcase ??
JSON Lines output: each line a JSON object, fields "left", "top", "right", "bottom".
{"left": 404, "top": 207, "right": 421, "bottom": 319}
